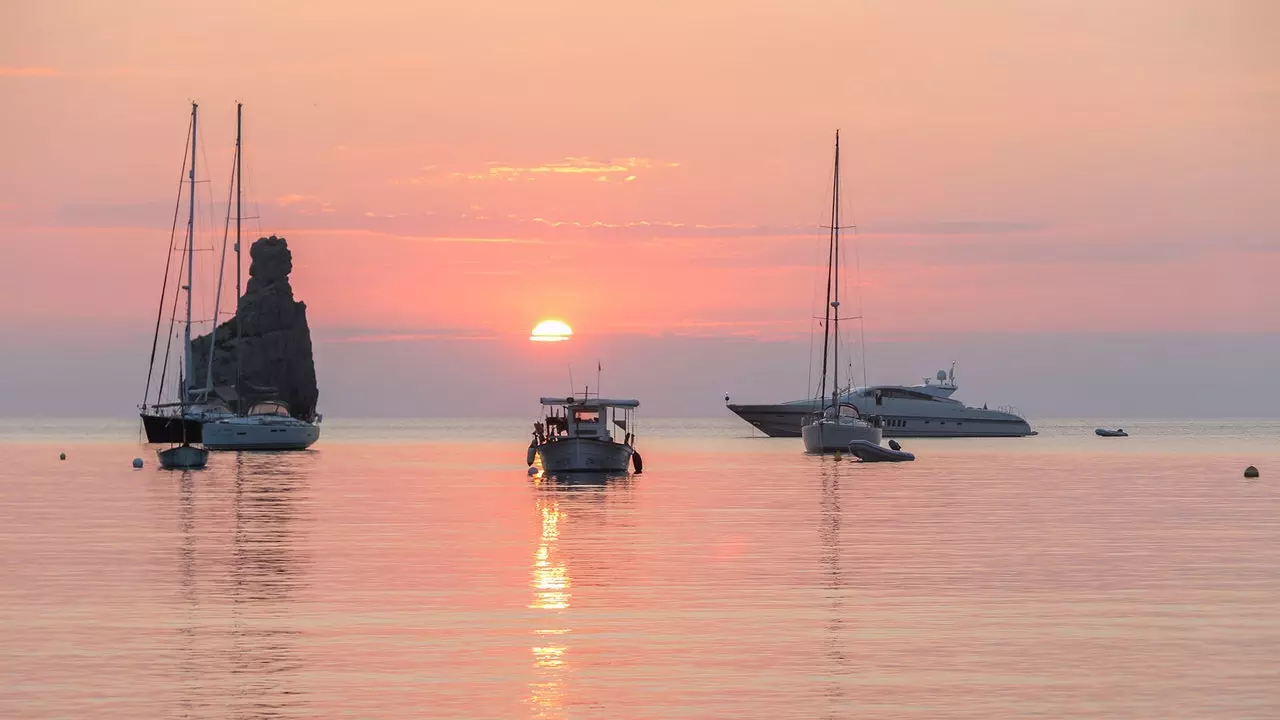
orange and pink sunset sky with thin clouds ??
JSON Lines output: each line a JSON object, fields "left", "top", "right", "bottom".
{"left": 0, "top": 0, "right": 1280, "bottom": 416}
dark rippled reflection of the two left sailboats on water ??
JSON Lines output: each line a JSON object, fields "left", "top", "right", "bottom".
{"left": 173, "top": 454, "right": 310, "bottom": 717}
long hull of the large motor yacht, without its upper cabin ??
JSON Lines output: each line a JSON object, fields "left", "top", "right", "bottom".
{"left": 728, "top": 404, "right": 1034, "bottom": 438}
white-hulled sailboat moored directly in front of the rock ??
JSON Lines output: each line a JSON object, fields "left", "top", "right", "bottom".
{"left": 201, "top": 104, "right": 320, "bottom": 450}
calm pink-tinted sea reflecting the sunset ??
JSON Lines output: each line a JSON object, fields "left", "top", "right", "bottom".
{"left": 0, "top": 419, "right": 1280, "bottom": 720}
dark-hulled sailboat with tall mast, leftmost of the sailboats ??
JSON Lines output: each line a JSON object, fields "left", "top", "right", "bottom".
{"left": 138, "top": 102, "right": 232, "bottom": 445}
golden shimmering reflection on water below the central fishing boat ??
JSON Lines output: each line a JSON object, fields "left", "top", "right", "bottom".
{"left": 527, "top": 471, "right": 631, "bottom": 717}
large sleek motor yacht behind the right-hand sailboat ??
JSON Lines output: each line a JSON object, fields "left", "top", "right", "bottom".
{"left": 726, "top": 365, "right": 1036, "bottom": 438}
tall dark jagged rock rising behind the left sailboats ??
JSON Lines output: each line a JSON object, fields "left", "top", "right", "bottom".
{"left": 191, "top": 234, "right": 320, "bottom": 420}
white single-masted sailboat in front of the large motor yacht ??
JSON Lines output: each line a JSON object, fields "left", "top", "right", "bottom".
{"left": 800, "top": 131, "right": 881, "bottom": 452}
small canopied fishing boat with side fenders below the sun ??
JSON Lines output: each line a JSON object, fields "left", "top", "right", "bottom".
{"left": 526, "top": 393, "right": 643, "bottom": 474}
